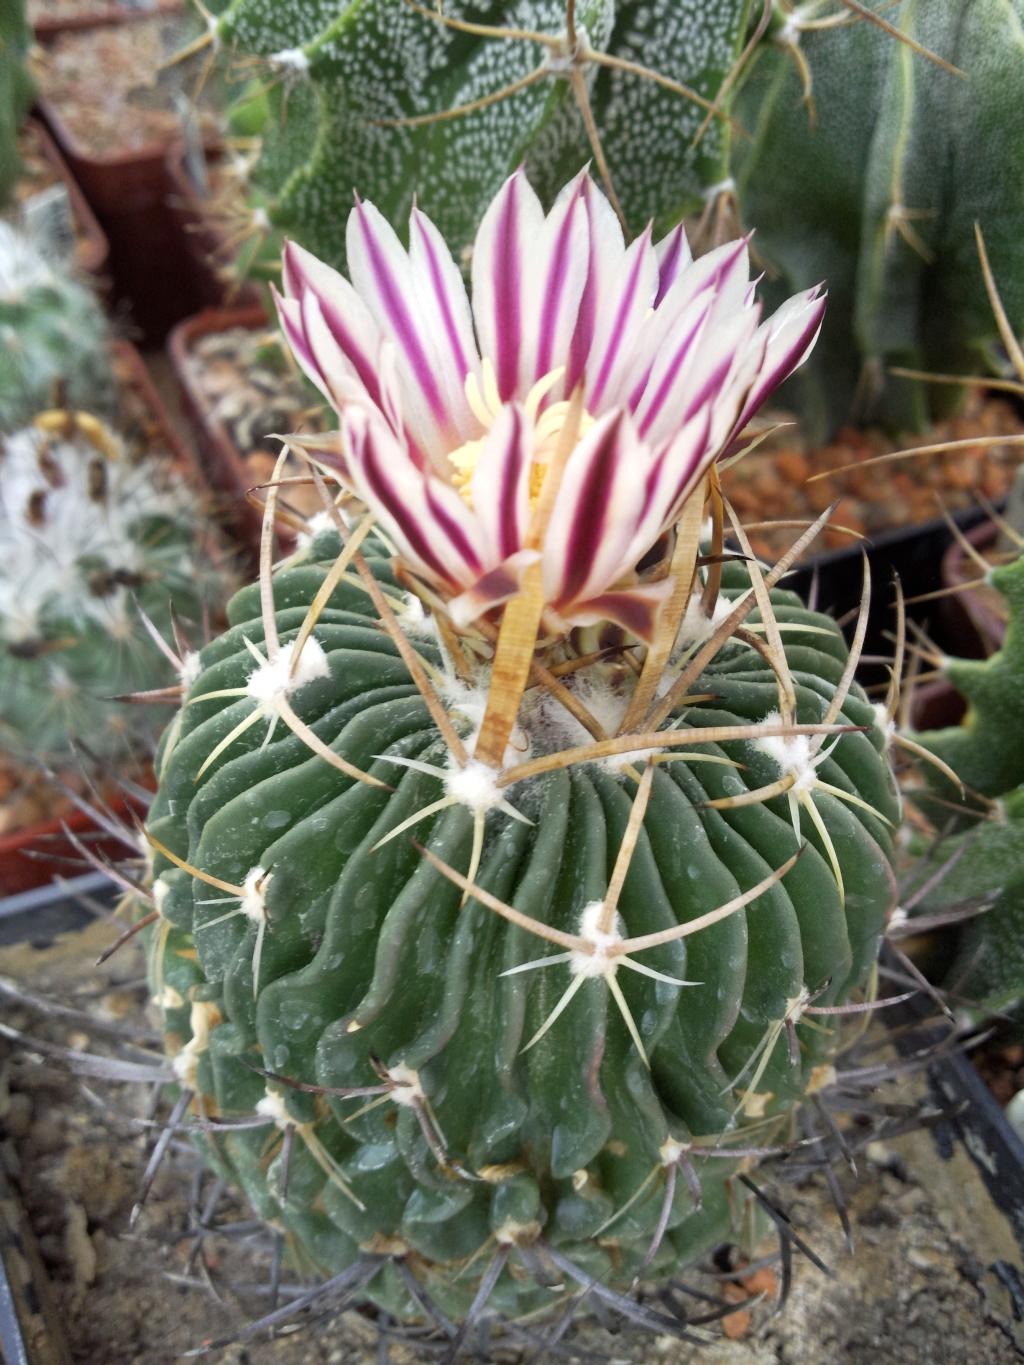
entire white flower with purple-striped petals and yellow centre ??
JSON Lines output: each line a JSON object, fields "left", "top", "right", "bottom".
{"left": 277, "top": 172, "right": 825, "bottom": 639}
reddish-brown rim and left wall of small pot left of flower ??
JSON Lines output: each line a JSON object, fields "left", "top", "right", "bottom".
{"left": 168, "top": 308, "right": 274, "bottom": 562}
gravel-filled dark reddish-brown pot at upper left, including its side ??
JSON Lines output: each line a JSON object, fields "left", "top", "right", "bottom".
{"left": 38, "top": 15, "right": 213, "bottom": 341}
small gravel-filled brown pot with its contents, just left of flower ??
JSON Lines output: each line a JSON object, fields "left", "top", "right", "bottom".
{"left": 169, "top": 308, "right": 330, "bottom": 551}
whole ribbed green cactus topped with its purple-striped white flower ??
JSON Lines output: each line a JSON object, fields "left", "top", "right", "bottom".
{"left": 140, "top": 167, "right": 898, "bottom": 1320}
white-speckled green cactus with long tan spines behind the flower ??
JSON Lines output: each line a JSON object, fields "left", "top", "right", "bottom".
{"left": 216, "top": 0, "right": 750, "bottom": 265}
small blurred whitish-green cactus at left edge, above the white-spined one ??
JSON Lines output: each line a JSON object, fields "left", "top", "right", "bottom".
{"left": 0, "top": 222, "right": 113, "bottom": 433}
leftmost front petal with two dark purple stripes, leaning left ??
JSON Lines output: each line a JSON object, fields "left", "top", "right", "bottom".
{"left": 341, "top": 408, "right": 487, "bottom": 590}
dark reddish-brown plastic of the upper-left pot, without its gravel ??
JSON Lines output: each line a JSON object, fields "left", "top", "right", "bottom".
{"left": 37, "top": 10, "right": 202, "bottom": 345}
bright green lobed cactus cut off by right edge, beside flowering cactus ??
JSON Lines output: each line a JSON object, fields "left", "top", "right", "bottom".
{"left": 915, "top": 556, "right": 1024, "bottom": 1010}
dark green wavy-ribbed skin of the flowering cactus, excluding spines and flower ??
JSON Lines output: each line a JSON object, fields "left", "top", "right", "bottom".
{"left": 150, "top": 536, "right": 898, "bottom": 1317}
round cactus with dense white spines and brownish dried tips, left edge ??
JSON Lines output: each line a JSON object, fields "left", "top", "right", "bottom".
{"left": 0, "top": 412, "right": 227, "bottom": 762}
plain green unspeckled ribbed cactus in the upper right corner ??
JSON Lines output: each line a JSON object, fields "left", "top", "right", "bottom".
{"left": 733, "top": 0, "right": 1024, "bottom": 435}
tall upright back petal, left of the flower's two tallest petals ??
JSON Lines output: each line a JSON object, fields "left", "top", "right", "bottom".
{"left": 472, "top": 171, "right": 543, "bottom": 403}
